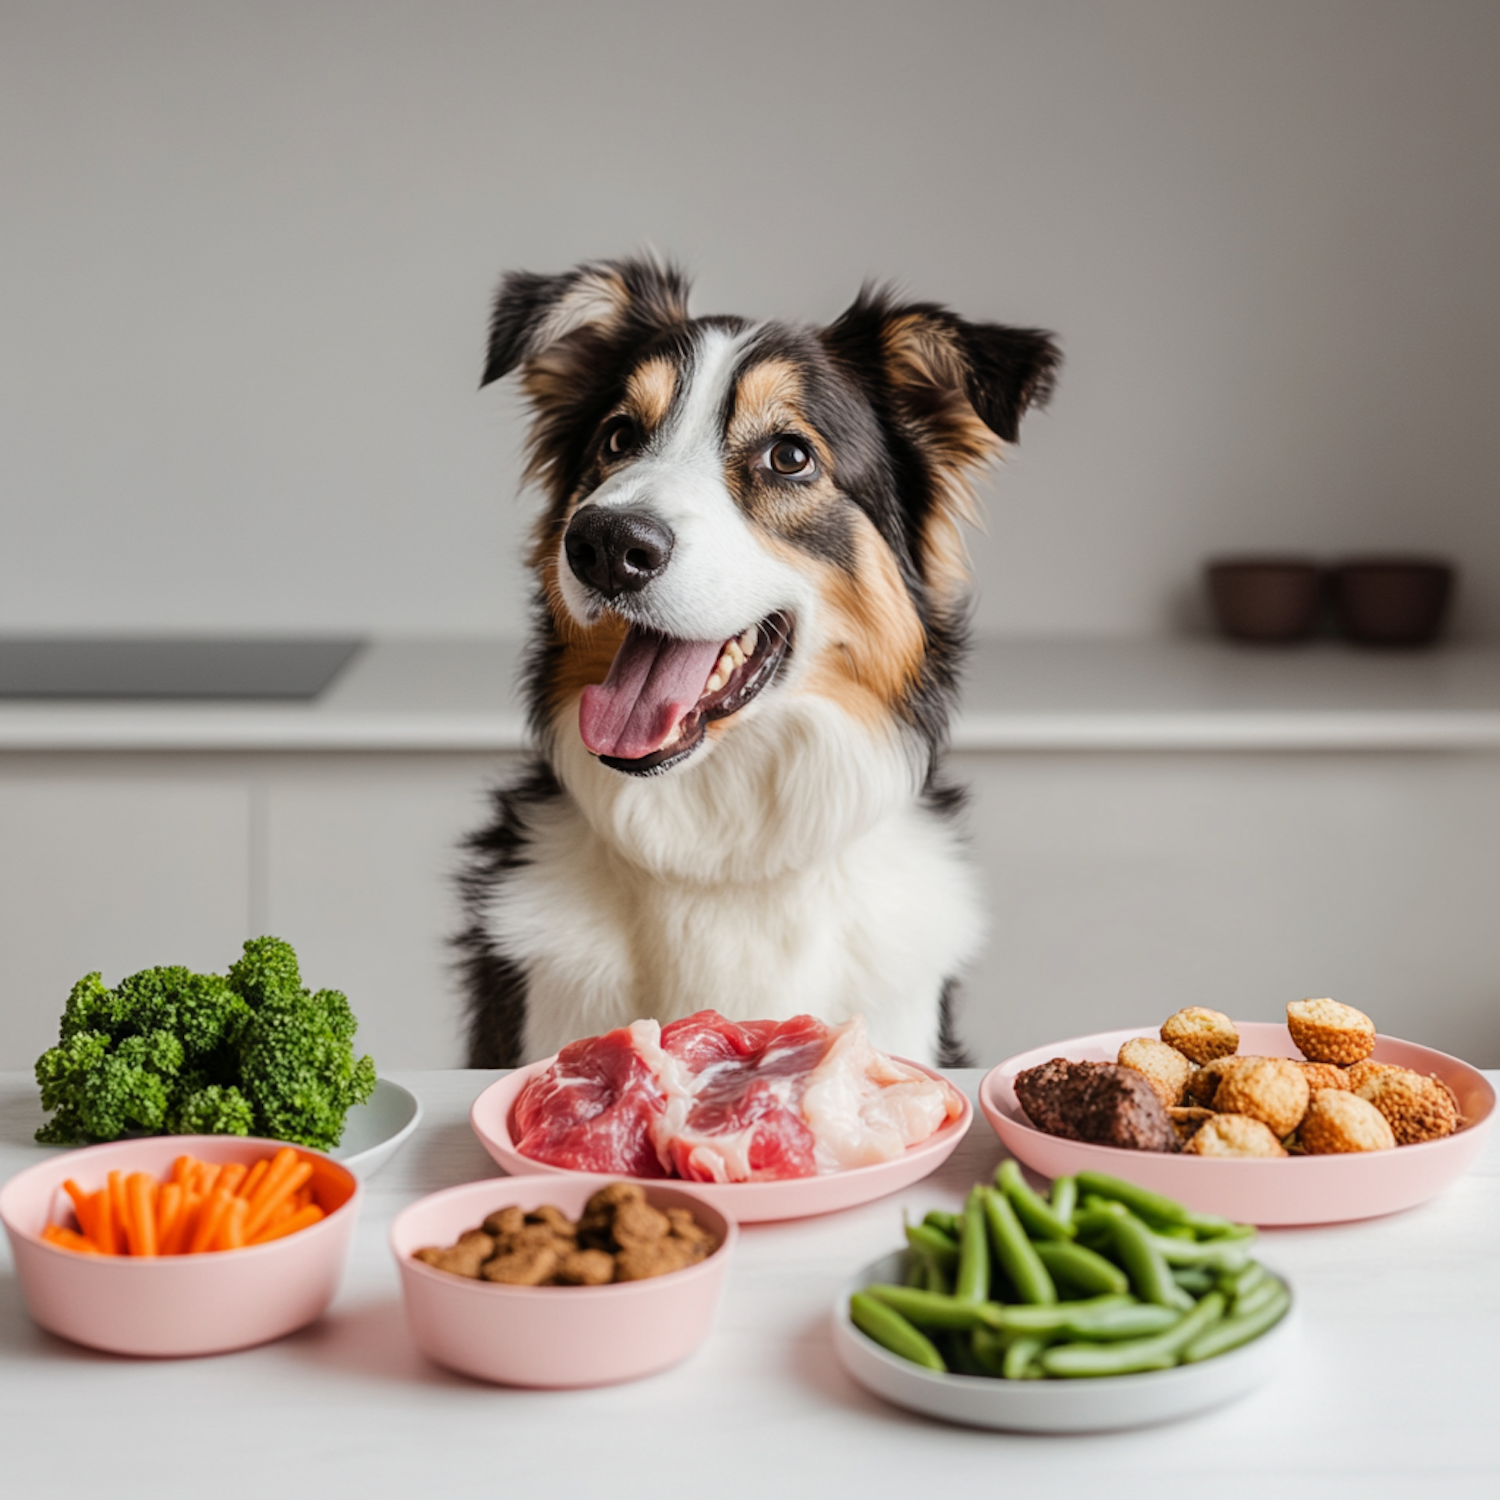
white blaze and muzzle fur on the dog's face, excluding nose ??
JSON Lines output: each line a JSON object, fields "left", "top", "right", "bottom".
{"left": 558, "top": 329, "right": 810, "bottom": 641}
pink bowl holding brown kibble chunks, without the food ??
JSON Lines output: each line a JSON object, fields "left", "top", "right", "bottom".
{"left": 390, "top": 1175, "right": 737, "bottom": 1388}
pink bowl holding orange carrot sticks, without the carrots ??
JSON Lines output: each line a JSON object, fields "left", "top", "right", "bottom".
{"left": 0, "top": 1136, "right": 360, "bottom": 1355}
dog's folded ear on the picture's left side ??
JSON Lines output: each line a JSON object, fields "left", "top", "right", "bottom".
{"left": 480, "top": 257, "right": 689, "bottom": 389}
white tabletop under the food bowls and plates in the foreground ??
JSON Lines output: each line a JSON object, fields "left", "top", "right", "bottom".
{"left": 0, "top": 1070, "right": 1500, "bottom": 1500}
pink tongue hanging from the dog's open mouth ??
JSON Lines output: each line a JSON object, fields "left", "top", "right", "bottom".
{"left": 578, "top": 626, "right": 722, "bottom": 761}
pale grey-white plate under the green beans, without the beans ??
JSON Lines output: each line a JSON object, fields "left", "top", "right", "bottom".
{"left": 834, "top": 1251, "right": 1298, "bottom": 1433}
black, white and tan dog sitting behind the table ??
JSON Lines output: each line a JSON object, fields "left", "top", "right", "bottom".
{"left": 455, "top": 258, "right": 1061, "bottom": 1068}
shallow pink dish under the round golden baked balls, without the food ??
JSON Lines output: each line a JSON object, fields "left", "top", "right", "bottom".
{"left": 980, "top": 1022, "right": 1496, "bottom": 1226}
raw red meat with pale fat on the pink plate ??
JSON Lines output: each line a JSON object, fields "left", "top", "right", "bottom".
{"left": 515, "top": 1011, "right": 963, "bottom": 1182}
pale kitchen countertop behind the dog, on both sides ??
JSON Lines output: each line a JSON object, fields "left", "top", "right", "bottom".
{"left": 0, "top": 639, "right": 1500, "bottom": 753}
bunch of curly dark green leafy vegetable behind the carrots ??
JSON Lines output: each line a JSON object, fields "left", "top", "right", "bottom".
{"left": 36, "top": 938, "right": 375, "bottom": 1151}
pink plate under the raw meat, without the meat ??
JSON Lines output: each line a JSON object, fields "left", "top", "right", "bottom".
{"left": 470, "top": 1058, "right": 974, "bottom": 1224}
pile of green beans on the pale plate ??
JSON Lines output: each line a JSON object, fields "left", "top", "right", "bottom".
{"left": 849, "top": 1161, "right": 1292, "bottom": 1380}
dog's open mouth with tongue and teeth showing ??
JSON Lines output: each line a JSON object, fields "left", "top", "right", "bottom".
{"left": 579, "top": 614, "right": 792, "bottom": 776}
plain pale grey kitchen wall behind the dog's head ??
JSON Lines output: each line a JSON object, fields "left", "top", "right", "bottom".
{"left": 0, "top": 0, "right": 1500, "bottom": 636}
